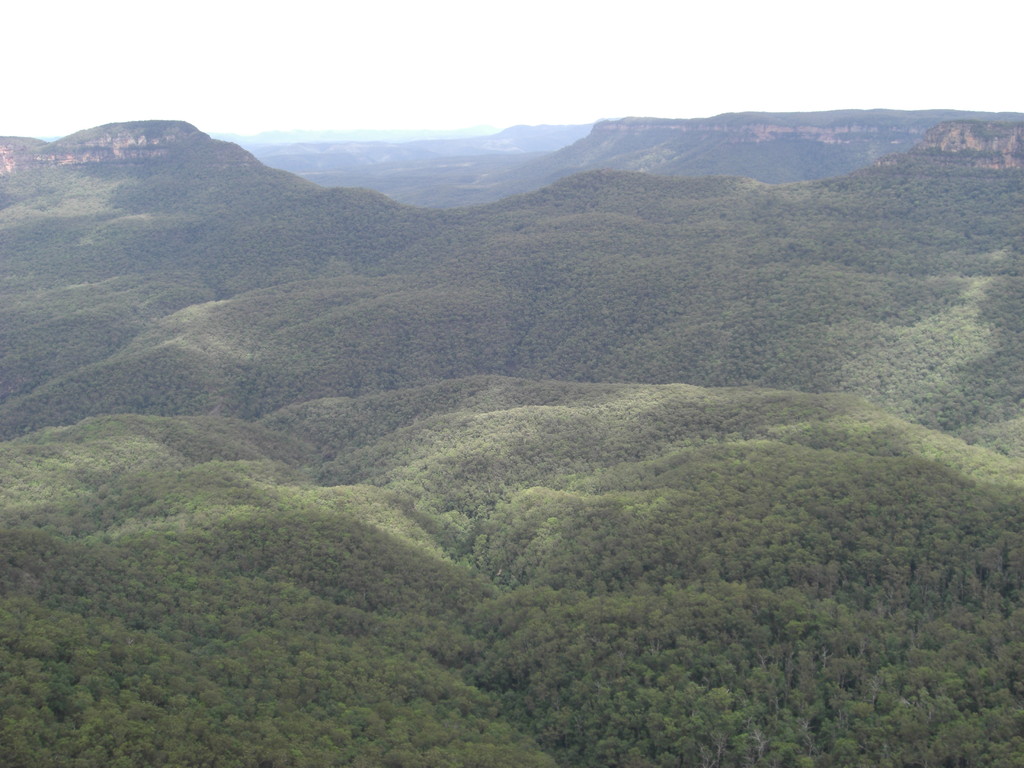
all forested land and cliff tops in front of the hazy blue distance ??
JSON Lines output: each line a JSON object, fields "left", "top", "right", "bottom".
{"left": 0, "top": 120, "right": 1024, "bottom": 768}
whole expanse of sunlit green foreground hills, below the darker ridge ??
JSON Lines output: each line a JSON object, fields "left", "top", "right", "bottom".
{"left": 0, "top": 377, "right": 1024, "bottom": 768}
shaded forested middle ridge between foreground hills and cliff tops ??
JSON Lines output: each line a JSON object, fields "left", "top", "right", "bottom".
{"left": 0, "top": 123, "right": 1024, "bottom": 451}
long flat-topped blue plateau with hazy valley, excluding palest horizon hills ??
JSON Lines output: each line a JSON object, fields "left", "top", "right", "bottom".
{"left": 265, "top": 110, "right": 1024, "bottom": 207}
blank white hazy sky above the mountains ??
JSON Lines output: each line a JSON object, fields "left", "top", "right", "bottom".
{"left": 8, "top": 0, "right": 1024, "bottom": 137}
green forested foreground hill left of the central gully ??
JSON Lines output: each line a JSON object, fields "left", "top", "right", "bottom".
{"left": 0, "top": 417, "right": 551, "bottom": 766}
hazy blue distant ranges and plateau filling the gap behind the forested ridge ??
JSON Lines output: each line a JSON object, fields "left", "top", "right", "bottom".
{"left": 242, "top": 110, "right": 1024, "bottom": 207}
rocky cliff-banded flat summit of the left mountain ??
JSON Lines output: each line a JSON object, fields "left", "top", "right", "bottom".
{"left": 0, "top": 121, "right": 256, "bottom": 174}
